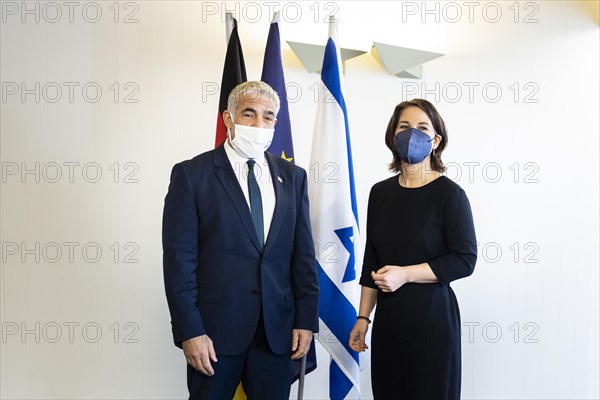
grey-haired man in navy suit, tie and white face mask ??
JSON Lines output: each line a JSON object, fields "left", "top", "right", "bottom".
{"left": 163, "top": 82, "right": 319, "bottom": 400}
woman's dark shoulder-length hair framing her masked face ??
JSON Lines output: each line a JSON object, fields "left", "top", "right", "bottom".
{"left": 385, "top": 99, "right": 448, "bottom": 173}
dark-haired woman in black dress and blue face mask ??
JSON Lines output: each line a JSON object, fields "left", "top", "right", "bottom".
{"left": 349, "top": 99, "right": 477, "bottom": 400}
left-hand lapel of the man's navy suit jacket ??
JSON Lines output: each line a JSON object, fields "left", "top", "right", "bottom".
{"left": 214, "top": 144, "right": 264, "bottom": 251}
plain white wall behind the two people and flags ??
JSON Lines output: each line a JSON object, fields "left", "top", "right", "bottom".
{"left": 0, "top": 1, "right": 600, "bottom": 399}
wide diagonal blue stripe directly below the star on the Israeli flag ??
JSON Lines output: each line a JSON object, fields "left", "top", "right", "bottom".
{"left": 317, "top": 261, "right": 358, "bottom": 363}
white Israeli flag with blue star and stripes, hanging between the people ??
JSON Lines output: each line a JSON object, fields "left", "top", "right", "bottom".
{"left": 308, "top": 18, "right": 360, "bottom": 400}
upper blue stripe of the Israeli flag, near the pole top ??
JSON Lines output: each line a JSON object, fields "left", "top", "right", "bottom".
{"left": 321, "top": 38, "right": 359, "bottom": 227}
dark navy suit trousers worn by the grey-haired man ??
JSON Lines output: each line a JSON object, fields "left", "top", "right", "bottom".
{"left": 187, "top": 311, "right": 292, "bottom": 400}
